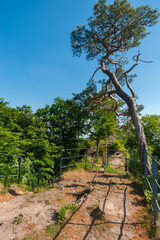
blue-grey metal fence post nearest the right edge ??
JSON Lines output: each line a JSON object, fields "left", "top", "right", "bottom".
{"left": 152, "top": 157, "right": 158, "bottom": 221}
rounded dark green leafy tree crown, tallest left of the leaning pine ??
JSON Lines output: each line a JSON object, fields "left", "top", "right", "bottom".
{"left": 36, "top": 97, "right": 85, "bottom": 149}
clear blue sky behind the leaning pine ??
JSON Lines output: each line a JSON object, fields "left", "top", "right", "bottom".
{"left": 0, "top": 0, "right": 160, "bottom": 114}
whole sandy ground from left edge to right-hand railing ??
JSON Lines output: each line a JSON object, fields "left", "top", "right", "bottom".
{"left": 0, "top": 170, "right": 149, "bottom": 240}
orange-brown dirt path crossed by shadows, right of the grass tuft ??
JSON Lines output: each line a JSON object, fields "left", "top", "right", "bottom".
{"left": 54, "top": 172, "right": 149, "bottom": 240}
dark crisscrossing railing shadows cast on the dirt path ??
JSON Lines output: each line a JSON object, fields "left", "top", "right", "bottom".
{"left": 53, "top": 171, "right": 144, "bottom": 240}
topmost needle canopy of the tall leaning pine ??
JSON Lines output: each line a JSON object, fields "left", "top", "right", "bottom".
{"left": 71, "top": 0, "right": 158, "bottom": 61}
